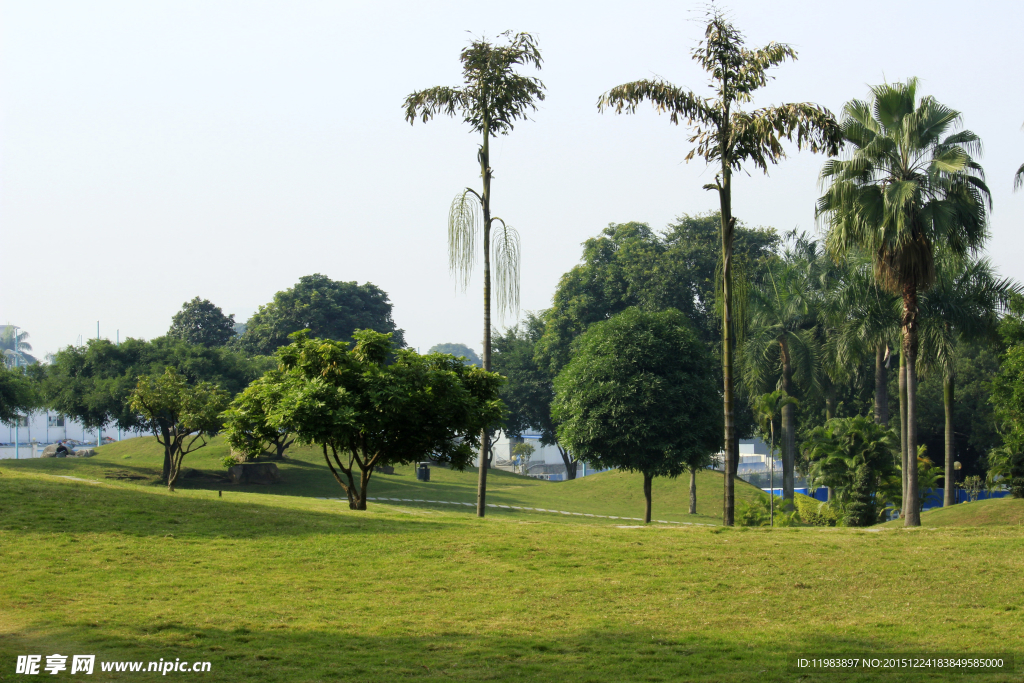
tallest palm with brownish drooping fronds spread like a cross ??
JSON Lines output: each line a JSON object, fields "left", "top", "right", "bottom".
{"left": 597, "top": 7, "right": 841, "bottom": 526}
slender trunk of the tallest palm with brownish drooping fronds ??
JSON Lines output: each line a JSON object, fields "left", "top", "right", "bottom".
{"left": 718, "top": 157, "right": 736, "bottom": 526}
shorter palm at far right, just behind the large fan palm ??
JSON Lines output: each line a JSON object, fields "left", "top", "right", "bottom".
{"left": 921, "top": 250, "right": 1021, "bottom": 506}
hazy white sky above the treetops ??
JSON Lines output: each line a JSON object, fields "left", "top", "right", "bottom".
{"left": 0, "top": 0, "right": 1024, "bottom": 356}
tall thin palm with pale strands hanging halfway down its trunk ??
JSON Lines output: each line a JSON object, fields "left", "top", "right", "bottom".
{"left": 404, "top": 31, "right": 544, "bottom": 517}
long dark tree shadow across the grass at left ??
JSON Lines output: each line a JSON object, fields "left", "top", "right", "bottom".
{"left": 0, "top": 477, "right": 452, "bottom": 539}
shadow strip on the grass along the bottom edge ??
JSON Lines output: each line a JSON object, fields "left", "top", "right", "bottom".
{"left": 0, "top": 622, "right": 1018, "bottom": 683}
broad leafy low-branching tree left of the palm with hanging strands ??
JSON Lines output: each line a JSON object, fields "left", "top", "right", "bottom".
{"left": 247, "top": 330, "right": 503, "bottom": 510}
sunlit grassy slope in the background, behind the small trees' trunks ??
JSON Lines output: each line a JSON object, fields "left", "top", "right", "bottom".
{"left": 2, "top": 437, "right": 770, "bottom": 523}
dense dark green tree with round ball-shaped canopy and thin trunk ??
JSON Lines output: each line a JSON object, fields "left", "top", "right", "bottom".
{"left": 552, "top": 308, "right": 722, "bottom": 522}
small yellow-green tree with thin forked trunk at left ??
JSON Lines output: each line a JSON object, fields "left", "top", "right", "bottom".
{"left": 129, "top": 368, "right": 229, "bottom": 490}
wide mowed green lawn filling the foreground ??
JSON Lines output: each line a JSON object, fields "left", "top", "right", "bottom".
{"left": 0, "top": 443, "right": 1024, "bottom": 682}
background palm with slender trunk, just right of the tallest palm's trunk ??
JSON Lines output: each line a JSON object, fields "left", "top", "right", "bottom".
{"left": 742, "top": 255, "right": 818, "bottom": 509}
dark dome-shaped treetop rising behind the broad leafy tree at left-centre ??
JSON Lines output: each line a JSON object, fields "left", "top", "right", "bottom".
{"left": 237, "top": 273, "right": 406, "bottom": 355}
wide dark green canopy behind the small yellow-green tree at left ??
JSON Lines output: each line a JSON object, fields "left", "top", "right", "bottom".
{"left": 41, "top": 337, "right": 275, "bottom": 430}
